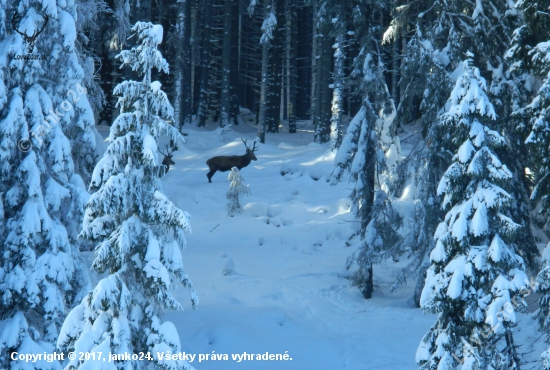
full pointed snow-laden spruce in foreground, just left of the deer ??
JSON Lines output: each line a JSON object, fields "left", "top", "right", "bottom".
{"left": 57, "top": 22, "right": 197, "bottom": 369}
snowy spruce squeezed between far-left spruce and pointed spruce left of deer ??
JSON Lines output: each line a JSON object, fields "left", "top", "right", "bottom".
{"left": 28, "top": 3, "right": 99, "bottom": 251}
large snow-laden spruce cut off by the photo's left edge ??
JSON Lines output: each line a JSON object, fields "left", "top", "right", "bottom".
{"left": 0, "top": 1, "right": 94, "bottom": 369}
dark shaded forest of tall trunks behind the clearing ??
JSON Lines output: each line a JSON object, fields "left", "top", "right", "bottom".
{"left": 86, "top": 0, "right": 412, "bottom": 142}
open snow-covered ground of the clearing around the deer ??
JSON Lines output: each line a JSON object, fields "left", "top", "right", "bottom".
{"left": 100, "top": 118, "right": 544, "bottom": 370}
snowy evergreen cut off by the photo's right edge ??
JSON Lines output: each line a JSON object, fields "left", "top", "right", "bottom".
{"left": 520, "top": 1, "right": 550, "bottom": 369}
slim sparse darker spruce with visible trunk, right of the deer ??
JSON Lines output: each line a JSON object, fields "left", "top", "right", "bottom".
{"left": 331, "top": 38, "right": 402, "bottom": 299}
